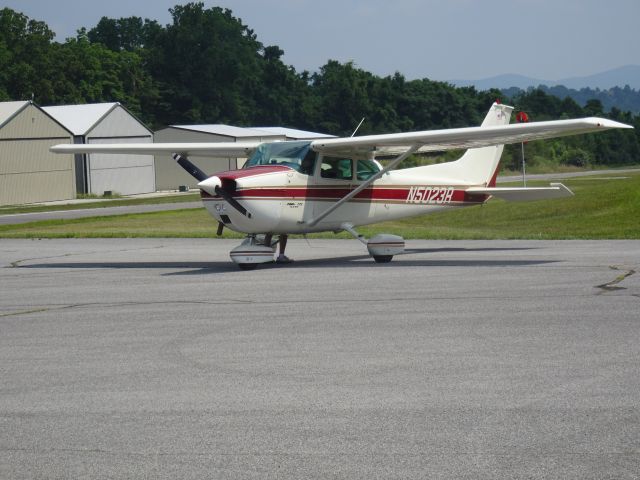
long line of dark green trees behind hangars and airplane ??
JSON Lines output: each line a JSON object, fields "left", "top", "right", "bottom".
{"left": 0, "top": 3, "right": 640, "bottom": 169}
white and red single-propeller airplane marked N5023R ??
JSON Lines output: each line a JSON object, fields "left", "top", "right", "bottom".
{"left": 51, "top": 102, "right": 633, "bottom": 270}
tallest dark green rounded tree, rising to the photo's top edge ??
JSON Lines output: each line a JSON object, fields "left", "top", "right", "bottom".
{"left": 142, "top": 3, "right": 262, "bottom": 124}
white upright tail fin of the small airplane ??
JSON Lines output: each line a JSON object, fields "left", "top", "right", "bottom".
{"left": 418, "top": 103, "right": 513, "bottom": 187}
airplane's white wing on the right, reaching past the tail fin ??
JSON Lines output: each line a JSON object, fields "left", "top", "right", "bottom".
{"left": 311, "top": 117, "right": 633, "bottom": 156}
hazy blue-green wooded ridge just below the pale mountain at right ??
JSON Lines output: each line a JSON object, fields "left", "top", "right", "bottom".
{"left": 502, "top": 85, "right": 640, "bottom": 114}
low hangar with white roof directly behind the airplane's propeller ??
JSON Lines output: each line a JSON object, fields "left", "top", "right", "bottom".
{"left": 154, "top": 125, "right": 330, "bottom": 190}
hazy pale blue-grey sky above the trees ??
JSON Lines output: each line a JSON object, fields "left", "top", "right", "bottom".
{"left": 6, "top": 0, "right": 640, "bottom": 80}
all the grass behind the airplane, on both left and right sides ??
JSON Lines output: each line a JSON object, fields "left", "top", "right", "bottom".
{"left": 0, "top": 174, "right": 640, "bottom": 239}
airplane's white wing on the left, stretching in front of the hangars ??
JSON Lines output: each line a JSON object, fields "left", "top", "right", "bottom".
{"left": 50, "top": 141, "right": 261, "bottom": 157}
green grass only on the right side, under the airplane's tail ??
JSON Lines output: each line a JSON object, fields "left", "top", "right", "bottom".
{"left": 363, "top": 175, "right": 640, "bottom": 239}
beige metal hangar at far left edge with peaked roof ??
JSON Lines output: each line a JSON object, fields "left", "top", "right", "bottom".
{"left": 0, "top": 101, "right": 76, "bottom": 205}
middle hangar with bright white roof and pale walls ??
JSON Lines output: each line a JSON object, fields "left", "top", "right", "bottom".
{"left": 43, "top": 103, "right": 156, "bottom": 195}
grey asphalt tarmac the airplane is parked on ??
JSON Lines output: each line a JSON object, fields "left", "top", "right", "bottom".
{"left": 0, "top": 239, "right": 640, "bottom": 479}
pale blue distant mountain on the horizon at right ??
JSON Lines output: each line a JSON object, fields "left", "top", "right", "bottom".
{"left": 449, "top": 65, "right": 640, "bottom": 91}
